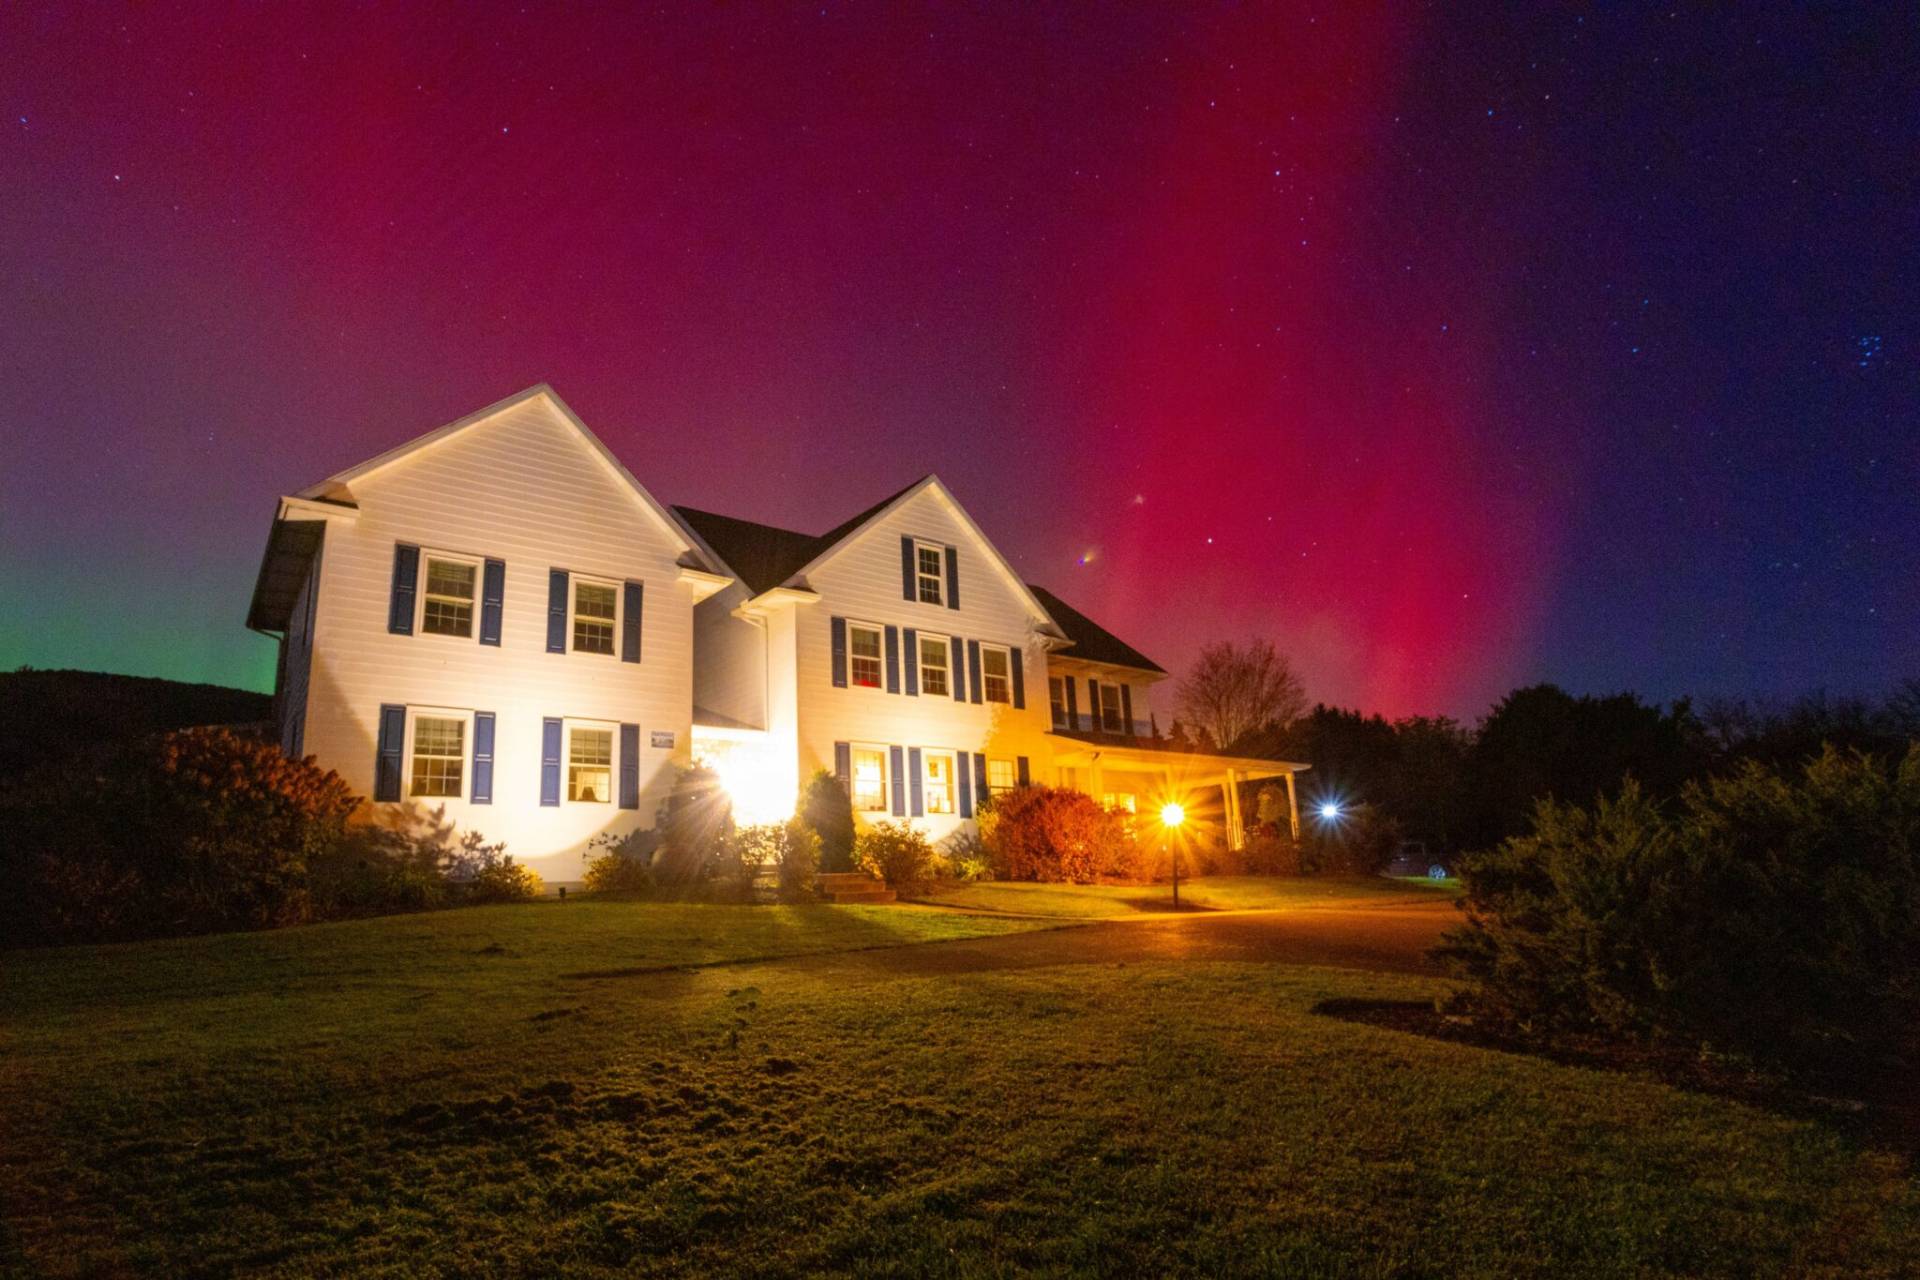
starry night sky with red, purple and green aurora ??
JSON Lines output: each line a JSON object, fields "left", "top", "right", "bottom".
{"left": 0, "top": 4, "right": 1920, "bottom": 718}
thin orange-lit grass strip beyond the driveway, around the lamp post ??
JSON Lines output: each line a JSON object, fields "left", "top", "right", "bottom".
{"left": 924, "top": 875, "right": 1459, "bottom": 919}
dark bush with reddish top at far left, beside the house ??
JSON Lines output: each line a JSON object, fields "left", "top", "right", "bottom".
{"left": 0, "top": 729, "right": 355, "bottom": 944}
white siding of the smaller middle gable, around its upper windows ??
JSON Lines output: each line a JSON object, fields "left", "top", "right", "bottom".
{"left": 776, "top": 489, "right": 1052, "bottom": 841}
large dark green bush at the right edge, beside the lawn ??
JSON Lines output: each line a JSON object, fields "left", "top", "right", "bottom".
{"left": 1440, "top": 747, "right": 1920, "bottom": 1079}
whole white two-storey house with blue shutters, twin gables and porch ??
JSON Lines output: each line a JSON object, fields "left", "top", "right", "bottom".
{"left": 248, "top": 386, "right": 1304, "bottom": 883}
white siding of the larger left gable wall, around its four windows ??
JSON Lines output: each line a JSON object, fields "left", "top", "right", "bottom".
{"left": 305, "top": 399, "right": 693, "bottom": 883}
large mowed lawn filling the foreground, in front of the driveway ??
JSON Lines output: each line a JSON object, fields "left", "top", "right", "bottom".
{"left": 0, "top": 904, "right": 1920, "bottom": 1276}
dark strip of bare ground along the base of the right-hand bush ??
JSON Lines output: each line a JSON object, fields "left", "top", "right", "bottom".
{"left": 1311, "top": 998, "right": 1920, "bottom": 1161}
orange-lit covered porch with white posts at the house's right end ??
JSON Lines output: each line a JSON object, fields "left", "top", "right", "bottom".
{"left": 1048, "top": 729, "right": 1309, "bottom": 848}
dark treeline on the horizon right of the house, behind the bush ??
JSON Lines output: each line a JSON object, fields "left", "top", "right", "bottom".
{"left": 1233, "top": 679, "right": 1920, "bottom": 852}
